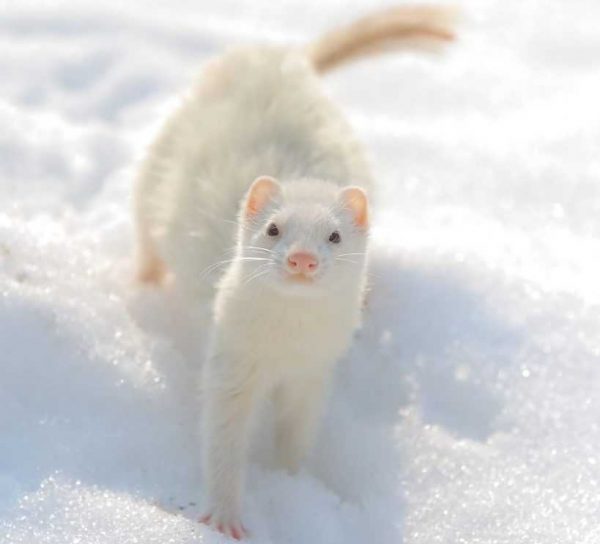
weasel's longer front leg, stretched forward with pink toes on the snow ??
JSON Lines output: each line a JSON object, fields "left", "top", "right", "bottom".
{"left": 201, "top": 360, "right": 257, "bottom": 539}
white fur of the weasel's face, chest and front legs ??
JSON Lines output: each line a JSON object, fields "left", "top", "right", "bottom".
{"left": 204, "top": 176, "right": 367, "bottom": 526}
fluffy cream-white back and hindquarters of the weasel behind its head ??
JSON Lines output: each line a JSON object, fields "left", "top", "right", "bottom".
{"left": 138, "top": 46, "right": 370, "bottom": 294}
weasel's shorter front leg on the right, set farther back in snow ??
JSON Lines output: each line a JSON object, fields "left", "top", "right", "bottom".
{"left": 275, "top": 376, "right": 329, "bottom": 473}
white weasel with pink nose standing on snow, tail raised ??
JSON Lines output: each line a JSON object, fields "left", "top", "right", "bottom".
{"left": 135, "top": 6, "right": 452, "bottom": 539}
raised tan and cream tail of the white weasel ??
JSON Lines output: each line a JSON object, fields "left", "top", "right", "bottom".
{"left": 307, "top": 5, "right": 457, "bottom": 73}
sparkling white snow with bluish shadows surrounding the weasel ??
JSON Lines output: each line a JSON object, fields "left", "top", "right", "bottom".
{"left": 0, "top": 0, "right": 600, "bottom": 544}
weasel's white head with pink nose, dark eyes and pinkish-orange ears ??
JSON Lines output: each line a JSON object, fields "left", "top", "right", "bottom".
{"left": 239, "top": 176, "right": 369, "bottom": 295}
